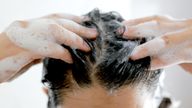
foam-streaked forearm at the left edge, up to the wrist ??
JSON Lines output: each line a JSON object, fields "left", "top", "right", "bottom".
{"left": 0, "top": 33, "right": 33, "bottom": 83}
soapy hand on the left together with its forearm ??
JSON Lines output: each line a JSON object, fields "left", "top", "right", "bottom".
{"left": 0, "top": 14, "right": 97, "bottom": 82}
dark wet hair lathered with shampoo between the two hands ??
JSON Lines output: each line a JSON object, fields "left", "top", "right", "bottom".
{"left": 42, "top": 9, "right": 161, "bottom": 108}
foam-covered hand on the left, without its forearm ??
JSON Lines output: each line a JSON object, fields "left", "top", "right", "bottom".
{"left": 4, "top": 14, "right": 96, "bottom": 63}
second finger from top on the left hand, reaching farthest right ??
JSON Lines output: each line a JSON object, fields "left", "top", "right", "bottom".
{"left": 56, "top": 19, "right": 98, "bottom": 38}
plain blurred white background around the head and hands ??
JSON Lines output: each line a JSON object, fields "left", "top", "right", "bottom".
{"left": 0, "top": 0, "right": 192, "bottom": 108}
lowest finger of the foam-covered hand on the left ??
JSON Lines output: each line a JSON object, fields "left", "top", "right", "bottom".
{"left": 37, "top": 42, "right": 73, "bottom": 63}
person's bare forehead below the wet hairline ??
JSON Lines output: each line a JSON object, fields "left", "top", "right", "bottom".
{"left": 59, "top": 86, "right": 154, "bottom": 108}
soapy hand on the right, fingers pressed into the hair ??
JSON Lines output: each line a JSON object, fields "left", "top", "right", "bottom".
{"left": 123, "top": 16, "right": 192, "bottom": 70}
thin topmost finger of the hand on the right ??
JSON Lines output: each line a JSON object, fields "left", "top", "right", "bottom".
{"left": 123, "top": 15, "right": 170, "bottom": 26}
